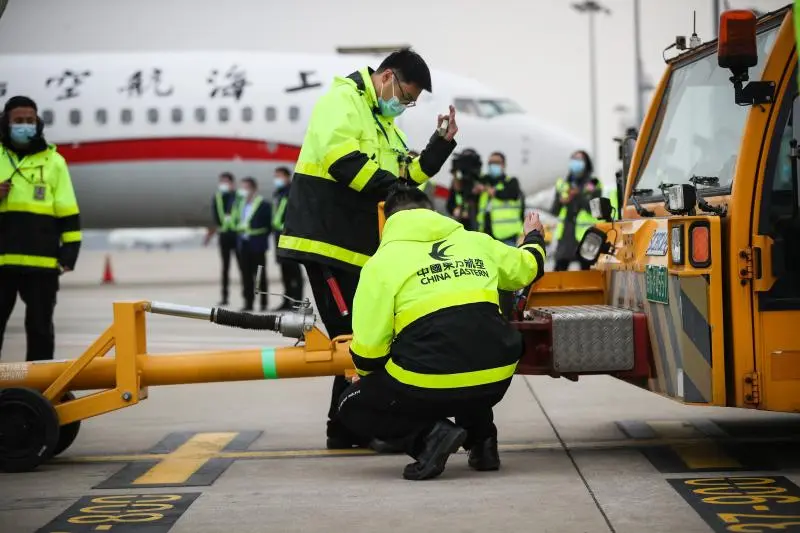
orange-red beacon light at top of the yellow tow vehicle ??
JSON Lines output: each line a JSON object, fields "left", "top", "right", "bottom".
{"left": 717, "top": 9, "right": 758, "bottom": 74}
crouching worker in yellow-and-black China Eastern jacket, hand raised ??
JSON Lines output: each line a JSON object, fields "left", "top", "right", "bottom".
{"left": 339, "top": 185, "right": 545, "bottom": 480}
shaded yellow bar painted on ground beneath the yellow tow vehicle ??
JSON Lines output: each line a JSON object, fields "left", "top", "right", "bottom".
{"left": 647, "top": 421, "right": 742, "bottom": 470}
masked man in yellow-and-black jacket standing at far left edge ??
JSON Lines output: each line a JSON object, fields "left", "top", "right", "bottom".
{"left": 0, "top": 96, "right": 81, "bottom": 361}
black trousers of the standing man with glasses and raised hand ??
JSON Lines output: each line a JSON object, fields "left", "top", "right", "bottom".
{"left": 303, "top": 263, "right": 362, "bottom": 443}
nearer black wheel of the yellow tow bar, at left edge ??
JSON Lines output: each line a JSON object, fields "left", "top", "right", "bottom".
{"left": 0, "top": 388, "right": 60, "bottom": 472}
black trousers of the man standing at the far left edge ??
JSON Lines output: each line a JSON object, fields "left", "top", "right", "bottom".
{"left": 0, "top": 268, "right": 59, "bottom": 361}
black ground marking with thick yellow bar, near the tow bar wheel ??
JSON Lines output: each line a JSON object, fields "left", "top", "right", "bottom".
{"left": 93, "top": 431, "right": 261, "bottom": 489}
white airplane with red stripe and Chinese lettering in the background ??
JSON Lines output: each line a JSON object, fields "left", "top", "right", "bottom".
{"left": 0, "top": 51, "right": 584, "bottom": 229}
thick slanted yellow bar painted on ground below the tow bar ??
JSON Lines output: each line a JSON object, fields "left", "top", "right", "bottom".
{"left": 133, "top": 433, "right": 238, "bottom": 485}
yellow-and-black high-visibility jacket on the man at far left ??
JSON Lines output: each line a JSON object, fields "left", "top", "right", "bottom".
{"left": 0, "top": 145, "right": 81, "bottom": 270}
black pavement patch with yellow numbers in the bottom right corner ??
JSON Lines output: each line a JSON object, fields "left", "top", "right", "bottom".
{"left": 667, "top": 476, "right": 800, "bottom": 533}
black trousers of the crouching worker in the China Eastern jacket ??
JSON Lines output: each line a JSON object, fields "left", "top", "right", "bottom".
{"left": 339, "top": 372, "right": 511, "bottom": 458}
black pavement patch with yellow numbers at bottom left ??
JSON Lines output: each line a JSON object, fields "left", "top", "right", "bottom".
{"left": 36, "top": 492, "right": 200, "bottom": 533}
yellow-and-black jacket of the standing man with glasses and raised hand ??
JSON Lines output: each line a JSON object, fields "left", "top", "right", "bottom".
{"left": 277, "top": 68, "right": 455, "bottom": 269}
